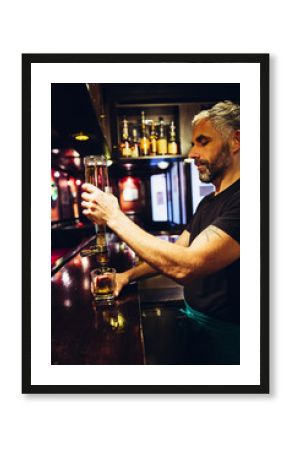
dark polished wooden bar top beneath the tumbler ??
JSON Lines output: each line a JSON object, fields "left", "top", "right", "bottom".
{"left": 51, "top": 237, "right": 145, "bottom": 364}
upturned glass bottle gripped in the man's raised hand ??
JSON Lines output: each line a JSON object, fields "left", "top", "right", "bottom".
{"left": 81, "top": 155, "right": 110, "bottom": 267}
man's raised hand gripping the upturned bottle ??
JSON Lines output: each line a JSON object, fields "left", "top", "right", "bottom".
{"left": 82, "top": 183, "right": 120, "bottom": 225}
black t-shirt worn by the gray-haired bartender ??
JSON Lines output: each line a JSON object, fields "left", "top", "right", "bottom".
{"left": 184, "top": 180, "right": 240, "bottom": 323}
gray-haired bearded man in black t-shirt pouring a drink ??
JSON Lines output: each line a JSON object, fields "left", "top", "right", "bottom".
{"left": 82, "top": 101, "right": 240, "bottom": 364}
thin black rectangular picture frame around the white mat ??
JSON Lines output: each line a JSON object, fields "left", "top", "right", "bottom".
{"left": 22, "top": 53, "right": 270, "bottom": 394}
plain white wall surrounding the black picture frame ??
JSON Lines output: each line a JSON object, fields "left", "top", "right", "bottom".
{"left": 0, "top": 0, "right": 290, "bottom": 450}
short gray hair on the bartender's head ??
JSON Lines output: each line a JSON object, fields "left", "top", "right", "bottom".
{"left": 192, "top": 100, "right": 240, "bottom": 138}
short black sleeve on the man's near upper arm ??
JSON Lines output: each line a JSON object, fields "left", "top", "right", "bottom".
{"left": 212, "top": 192, "right": 240, "bottom": 243}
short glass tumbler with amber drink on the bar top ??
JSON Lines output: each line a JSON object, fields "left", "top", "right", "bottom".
{"left": 91, "top": 267, "right": 116, "bottom": 304}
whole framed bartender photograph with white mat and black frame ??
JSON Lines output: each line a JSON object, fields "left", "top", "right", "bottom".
{"left": 22, "top": 54, "right": 269, "bottom": 394}
